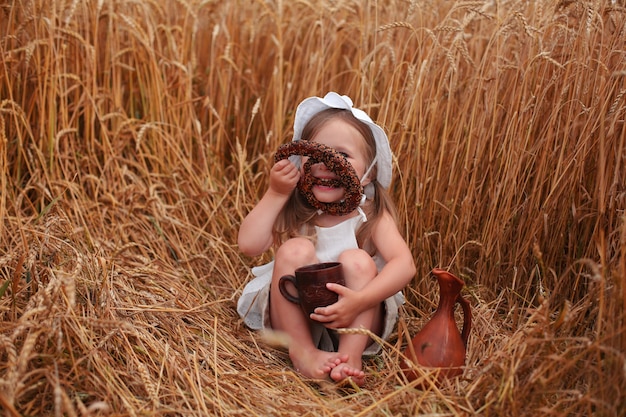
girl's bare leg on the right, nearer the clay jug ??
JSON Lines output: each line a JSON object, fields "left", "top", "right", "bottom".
{"left": 330, "top": 250, "right": 383, "bottom": 386}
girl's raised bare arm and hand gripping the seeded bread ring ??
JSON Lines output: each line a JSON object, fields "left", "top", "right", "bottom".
{"left": 237, "top": 159, "right": 300, "bottom": 256}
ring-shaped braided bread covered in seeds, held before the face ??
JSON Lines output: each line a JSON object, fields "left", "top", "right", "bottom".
{"left": 274, "top": 140, "right": 363, "bottom": 216}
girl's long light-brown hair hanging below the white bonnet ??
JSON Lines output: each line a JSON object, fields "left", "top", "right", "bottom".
{"left": 274, "top": 108, "right": 397, "bottom": 255}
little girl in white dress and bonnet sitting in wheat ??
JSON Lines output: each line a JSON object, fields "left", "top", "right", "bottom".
{"left": 237, "top": 92, "right": 415, "bottom": 385}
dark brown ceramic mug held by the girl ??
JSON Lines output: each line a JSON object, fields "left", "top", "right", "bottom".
{"left": 278, "top": 262, "right": 345, "bottom": 315}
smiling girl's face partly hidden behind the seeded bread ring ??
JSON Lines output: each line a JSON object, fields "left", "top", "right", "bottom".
{"left": 311, "top": 118, "right": 369, "bottom": 203}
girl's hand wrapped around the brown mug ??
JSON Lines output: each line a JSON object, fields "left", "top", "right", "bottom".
{"left": 310, "top": 283, "right": 363, "bottom": 329}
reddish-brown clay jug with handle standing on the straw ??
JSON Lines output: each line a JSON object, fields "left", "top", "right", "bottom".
{"left": 401, "top": 268, "right": 472, "bottom": 382}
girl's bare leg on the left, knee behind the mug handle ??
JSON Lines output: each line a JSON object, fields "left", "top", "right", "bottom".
{"left": 270, "top": 238, "right": 348, "bottom": 379}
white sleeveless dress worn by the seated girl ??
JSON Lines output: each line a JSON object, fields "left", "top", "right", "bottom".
{"left": 237, "top": 214, "right": 404, "bottom": 355}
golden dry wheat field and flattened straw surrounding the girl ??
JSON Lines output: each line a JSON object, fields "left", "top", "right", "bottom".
{"left": 0, "top": 0, "right": 626, "bottom": 416}
